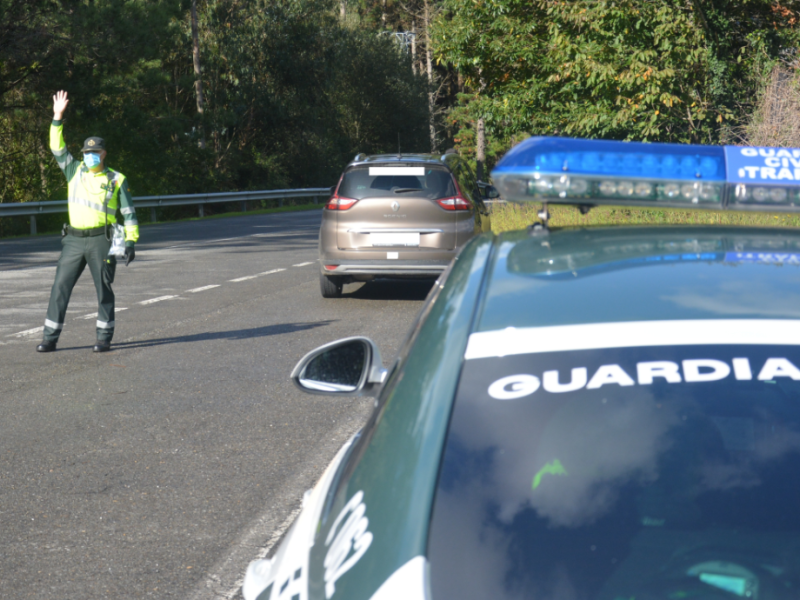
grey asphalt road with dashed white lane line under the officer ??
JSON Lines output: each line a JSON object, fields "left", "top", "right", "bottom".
{"left": 0, "top": 211, "right": 431, "bottom": 600}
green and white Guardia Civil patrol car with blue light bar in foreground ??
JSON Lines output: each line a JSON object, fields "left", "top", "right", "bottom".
{"left": 243, "top": 138, "right": 800, "bottom": 600}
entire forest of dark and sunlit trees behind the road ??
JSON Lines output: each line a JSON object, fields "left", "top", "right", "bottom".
{"left": 0, "top": 0, "right": 800, "bottom": 235}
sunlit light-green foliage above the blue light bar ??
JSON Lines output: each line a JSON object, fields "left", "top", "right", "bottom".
{"left": 433, "top": 0, "right": 797, "bottom": 149}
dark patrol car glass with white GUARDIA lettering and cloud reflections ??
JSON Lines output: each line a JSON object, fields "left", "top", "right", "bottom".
{"left": 429, "top": 345, "right": 800, "bottom": 600}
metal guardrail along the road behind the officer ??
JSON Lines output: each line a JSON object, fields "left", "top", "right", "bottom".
{"left": 0, "top": 188, "right": 331, "bottom": 235}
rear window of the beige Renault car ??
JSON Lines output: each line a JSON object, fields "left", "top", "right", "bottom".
{"left": 339, "top": 165, "right": 456, "bottom": 200}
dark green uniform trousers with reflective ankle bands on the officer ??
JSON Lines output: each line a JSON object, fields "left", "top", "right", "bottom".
{"left": 44, "top": 234, "right": 117, "bottom": 342}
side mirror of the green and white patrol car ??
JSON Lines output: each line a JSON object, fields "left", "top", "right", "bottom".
{"left": 292, "top": 337, "right": 386, "bottom": 396}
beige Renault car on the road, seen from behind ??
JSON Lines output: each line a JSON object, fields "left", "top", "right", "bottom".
{"left": 319, "top": 152, "right": 497, "bottom": 298}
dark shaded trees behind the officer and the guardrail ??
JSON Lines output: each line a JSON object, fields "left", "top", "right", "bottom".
{"left": 0, "top": 0, "right": 427, "bottom": 214}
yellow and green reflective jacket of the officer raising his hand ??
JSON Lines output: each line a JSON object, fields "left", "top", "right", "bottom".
{"left": 50, "top": 121, "right": 139, "bottom": 246}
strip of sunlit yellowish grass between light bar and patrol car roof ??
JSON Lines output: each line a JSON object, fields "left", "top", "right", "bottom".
{"left": 492, "top": 202, "right": 800, "bottom": 233}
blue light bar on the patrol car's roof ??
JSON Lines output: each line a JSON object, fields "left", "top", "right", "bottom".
{"left": 492, "top": 137, "right": 800, "bottom": 211}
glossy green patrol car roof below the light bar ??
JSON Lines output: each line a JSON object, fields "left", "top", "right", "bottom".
{"left": 475, "top": 227, "right": 800, "bottom": 331}
